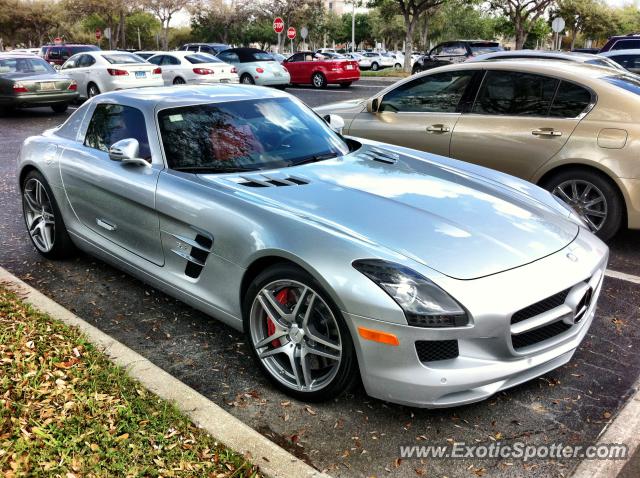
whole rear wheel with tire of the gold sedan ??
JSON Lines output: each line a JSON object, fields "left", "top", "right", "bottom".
{"left": 542, "top": 168, "right": 624, "bottom": 241}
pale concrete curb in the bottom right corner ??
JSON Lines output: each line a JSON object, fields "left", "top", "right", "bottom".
{"left": 571, "top": 380, "right": 640, "bottom": 478}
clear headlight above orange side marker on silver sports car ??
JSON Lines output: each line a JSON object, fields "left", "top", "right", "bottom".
{"left": 353, "top": 259, "right": 469, "bottom": 327}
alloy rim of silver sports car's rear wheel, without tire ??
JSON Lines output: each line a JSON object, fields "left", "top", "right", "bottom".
{"left": 22, "top": 178, "right": 55, "bottom": 252}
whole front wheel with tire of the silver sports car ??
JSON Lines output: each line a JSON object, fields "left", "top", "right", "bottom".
{"left": 243, "top": 264, "right": 358, "bottom": 401}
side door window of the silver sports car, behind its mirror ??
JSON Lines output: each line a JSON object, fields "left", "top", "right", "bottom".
{"left": 84, "top": 104, "right": 151, "bottom": 160}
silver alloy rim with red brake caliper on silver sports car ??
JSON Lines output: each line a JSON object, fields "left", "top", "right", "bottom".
{"left": 249, "top": 279, "right": 343, "bottom": 392}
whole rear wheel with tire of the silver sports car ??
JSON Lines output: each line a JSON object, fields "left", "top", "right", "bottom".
{"left": 22, "top": 170, "right": 74, "bottom": 259}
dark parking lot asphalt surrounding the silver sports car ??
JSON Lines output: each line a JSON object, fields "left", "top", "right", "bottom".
{"left": 0, "top": 88, "right": 640, "bottom": 477}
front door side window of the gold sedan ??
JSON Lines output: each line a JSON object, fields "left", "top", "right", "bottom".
{"left": 379, "top": 71, "right": 474, "bottom": 113}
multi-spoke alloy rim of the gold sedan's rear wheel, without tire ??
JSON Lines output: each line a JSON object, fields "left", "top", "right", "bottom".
{"left": 552, "top": 179, "right": 608, "bottom": 232}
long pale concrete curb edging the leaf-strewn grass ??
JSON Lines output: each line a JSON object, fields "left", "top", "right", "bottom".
{"left": 0, "top": 267, "right": 331, "bottom": 478}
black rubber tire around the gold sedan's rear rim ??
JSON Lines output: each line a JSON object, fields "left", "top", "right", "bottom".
{"left": 540, "top": 168, "right": 625, "bottom": 241}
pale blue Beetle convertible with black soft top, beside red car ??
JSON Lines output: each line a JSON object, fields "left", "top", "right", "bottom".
{"left": 217, "top": 48, "right": 291, "bottom": 88}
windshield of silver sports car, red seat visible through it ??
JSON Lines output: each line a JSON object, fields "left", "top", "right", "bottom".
{"left": 158, "top": 98, "right": 349, "bottom": 172}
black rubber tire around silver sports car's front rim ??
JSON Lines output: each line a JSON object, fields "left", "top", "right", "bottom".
{"left": 242, "top": 264, "right": 360, "bottom": 402}
